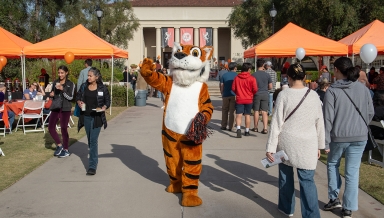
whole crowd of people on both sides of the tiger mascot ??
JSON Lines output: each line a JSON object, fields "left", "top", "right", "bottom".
{"left": 0, "top": 54, "right": 384, "bottom": 217}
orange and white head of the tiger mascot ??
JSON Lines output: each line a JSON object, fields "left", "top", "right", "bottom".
{"left": 169, "top": 42, "right": 213, "bottom": 86}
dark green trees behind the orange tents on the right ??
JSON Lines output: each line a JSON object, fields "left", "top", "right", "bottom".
{"left": 228, "top": 0, "right": 384, "bottom": 48}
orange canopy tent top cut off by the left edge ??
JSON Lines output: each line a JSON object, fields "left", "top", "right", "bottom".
{"left": 0, "top": 27, "right": 32, "bottom": 58}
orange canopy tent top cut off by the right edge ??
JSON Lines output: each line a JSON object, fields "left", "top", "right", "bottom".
{"left": 339, "top": 20, "right": 384, "bottom": 54}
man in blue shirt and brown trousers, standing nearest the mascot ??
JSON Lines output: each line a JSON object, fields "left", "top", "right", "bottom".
{"left": 220, "top": 62, "right": 237, "bottom": 131}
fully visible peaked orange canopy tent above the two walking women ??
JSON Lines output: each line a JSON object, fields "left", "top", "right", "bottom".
{"left": 24, "top": 24, "right": 128, "bottom": 113}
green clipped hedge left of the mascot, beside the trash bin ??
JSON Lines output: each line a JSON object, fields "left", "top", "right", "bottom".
{"left": 108, "top": 85, "right": 135, "bottom": 107}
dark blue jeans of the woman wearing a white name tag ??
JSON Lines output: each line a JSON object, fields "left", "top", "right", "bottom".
{"left": 84, "top": 116, "right": 101, "bottom": 170}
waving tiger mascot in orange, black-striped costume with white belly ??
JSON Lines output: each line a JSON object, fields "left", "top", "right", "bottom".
{"left": 140, "top": 42, "right": 213, "bottom": 207}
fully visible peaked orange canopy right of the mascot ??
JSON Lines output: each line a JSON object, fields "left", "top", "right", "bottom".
{"left": 244, "top": 23, "right": 348, "bottom": 58}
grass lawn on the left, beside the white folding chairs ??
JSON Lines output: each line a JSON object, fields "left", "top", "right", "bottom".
{"left": 0, "top": 107, "right": 127, "bottom": 191}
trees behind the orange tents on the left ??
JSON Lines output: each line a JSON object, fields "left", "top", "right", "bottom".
{"left": 0, "top": 0, "right": 139, "bottom": 81}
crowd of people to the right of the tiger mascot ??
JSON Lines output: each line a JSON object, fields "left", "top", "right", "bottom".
{"left": 220, "top": 57, "right": 376, "bottom": 217}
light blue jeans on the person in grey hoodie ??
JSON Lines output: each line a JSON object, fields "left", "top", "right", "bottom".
{"left": 327, "top": 141, "right": 367, "bottom": 211}
